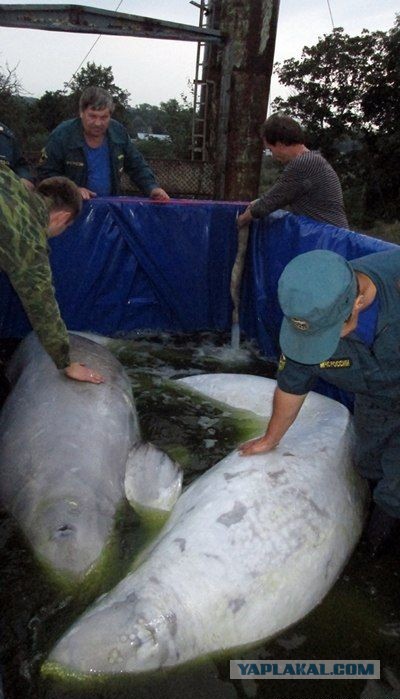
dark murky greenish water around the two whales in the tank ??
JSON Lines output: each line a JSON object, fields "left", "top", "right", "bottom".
{"left": 0, "top": 334, "right": 400, "bottom": 699}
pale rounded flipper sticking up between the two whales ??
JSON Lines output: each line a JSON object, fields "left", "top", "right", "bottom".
{"left": 125, "top": 443, "right": 183, "bottom": 517}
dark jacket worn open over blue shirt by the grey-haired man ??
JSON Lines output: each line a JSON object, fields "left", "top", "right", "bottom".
{"left": 38, "top": 117, "right": 158, "bottom": 196}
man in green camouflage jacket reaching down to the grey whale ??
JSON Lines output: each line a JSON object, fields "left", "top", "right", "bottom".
{"left": 0, "top": 163, "right": 103, "bottom": 383}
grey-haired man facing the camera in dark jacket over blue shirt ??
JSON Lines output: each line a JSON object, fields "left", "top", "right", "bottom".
{"left": 39, "top": 87, "right": 169, "bottom": 201}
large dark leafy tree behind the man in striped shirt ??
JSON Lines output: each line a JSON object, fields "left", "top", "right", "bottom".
{"left": 272, "top": 17, "right": 400, "bottom": 226}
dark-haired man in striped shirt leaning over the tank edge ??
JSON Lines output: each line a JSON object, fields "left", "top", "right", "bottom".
{"left": 238, "top": 114, "right": 349, "bottom": 228}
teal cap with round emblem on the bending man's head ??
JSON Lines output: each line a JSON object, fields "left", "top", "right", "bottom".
{"left": 278, "top": 250, "right": 357, "bottom": 364}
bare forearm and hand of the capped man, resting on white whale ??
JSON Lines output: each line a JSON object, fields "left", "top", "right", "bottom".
{"left": 239, "top": 386, "right": 307, "bottom": 456}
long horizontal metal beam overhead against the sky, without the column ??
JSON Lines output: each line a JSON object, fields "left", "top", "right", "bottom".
{"left": 0, "top": 5, "right": 223, "bottom": 44}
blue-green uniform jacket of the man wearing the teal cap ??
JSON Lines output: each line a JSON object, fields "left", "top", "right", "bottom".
{"left": 277, "top": 248, "right": 400, "bottom": 412}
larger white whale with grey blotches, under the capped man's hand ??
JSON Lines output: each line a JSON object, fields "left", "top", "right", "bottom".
{"left": 42, "top": 374, "right": 366, "bottom": 677}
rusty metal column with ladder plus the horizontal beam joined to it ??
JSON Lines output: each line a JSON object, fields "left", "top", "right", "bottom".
{"left": 0, "top": 0, "right": 279, "bottom": 200}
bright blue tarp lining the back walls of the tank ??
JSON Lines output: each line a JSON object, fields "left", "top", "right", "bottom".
{"left": 0, "top": 198, "right": 390, "bottom": 404}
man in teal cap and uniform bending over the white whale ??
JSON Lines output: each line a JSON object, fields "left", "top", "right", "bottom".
{"left": 241, "top": 247, "right": 400, "bottom": 554}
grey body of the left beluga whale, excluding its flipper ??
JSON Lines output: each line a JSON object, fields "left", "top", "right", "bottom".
{"left": 0, "top": 333, "right": 140, "bottom": 583}
